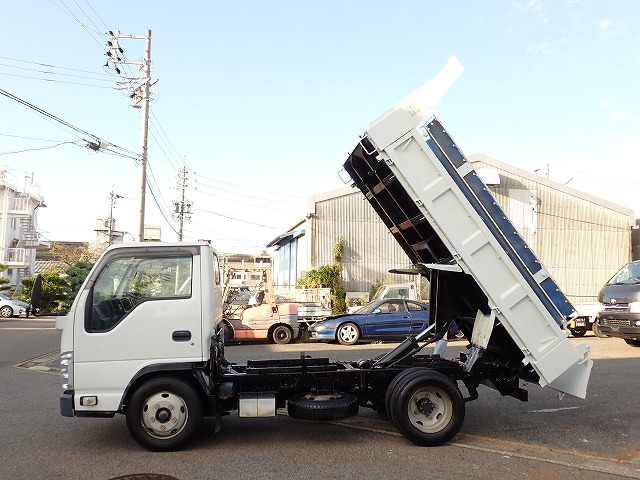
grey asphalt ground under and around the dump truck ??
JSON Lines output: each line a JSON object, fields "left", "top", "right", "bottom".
{"left": 0, "top": 318, "right": 640, "bottom": 480}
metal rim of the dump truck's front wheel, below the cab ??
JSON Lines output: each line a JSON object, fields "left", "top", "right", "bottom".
{"left": 140, "top": 392, "right": 189, "bottom": 439}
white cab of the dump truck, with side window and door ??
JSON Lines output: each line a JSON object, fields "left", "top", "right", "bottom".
{"left": 56, "top": 242, "right": 222, "bottom": 416}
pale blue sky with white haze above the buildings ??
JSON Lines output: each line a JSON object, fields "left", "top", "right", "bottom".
{"left": 0, "top": 0, "right": 640, "bottom": 253}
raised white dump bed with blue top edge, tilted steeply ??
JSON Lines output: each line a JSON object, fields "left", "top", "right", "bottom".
{"left": 344, "top": 55, "right": 592, "bottom": 398}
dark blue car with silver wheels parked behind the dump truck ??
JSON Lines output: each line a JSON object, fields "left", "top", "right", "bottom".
{"left": 309, "top": 298, "right": 429, "bottom": 345}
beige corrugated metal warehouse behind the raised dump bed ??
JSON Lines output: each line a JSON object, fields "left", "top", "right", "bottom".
{"left": 269, "top": 154, "right": 635, "bottom": 303}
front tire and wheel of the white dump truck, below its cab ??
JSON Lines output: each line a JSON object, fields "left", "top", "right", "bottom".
{"left": 125, "top": 377, "right": 203, "bottom": 452}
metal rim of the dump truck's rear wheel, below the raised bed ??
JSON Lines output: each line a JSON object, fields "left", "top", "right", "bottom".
{"left": 408, "top": 386, "right": 453, "bottom": 433}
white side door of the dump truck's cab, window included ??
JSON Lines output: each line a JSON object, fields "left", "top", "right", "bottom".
{"left": 74, "top": 248, "right": 206, "bottom": 410}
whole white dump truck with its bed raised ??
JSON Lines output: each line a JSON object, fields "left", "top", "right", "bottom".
{"left": 56, "top": 58, "right": 592, "bottom": 451}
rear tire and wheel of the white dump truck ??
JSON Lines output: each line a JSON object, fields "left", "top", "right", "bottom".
{"left": 390, "top": 369, "right": 465, "bottom": 447}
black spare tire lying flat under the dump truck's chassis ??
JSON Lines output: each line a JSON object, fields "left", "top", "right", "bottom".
{"left": 287, "top": 392, "right": 360, "bottom": 421}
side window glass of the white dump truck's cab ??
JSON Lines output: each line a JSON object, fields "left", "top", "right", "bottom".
{"left": 85, "top": 255, "right": 193, "bottom": 332}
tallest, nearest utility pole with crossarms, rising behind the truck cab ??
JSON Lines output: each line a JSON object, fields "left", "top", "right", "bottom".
{"left": 106, "top": 29, "right": 155, "bottom": 242}
